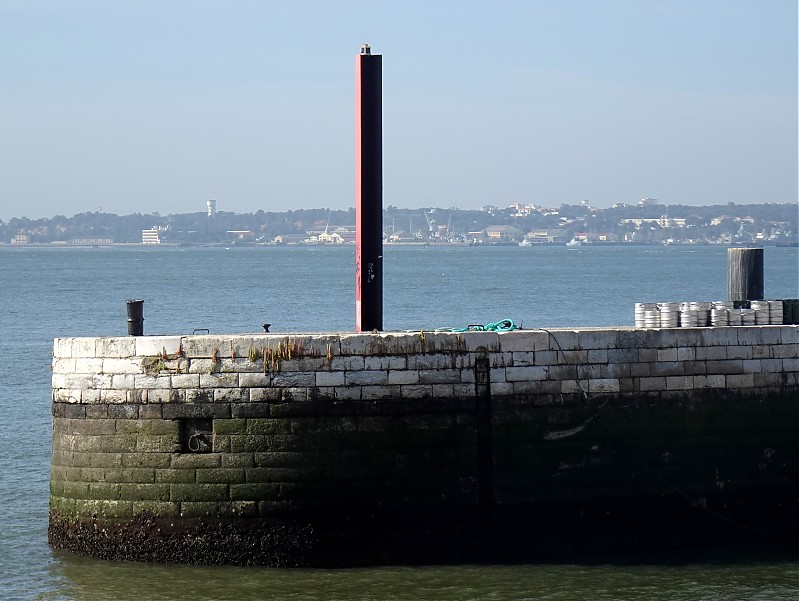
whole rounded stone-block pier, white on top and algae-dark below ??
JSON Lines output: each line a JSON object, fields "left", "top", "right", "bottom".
{"left": 49, "top": 326, "right": 799, "bottom": 566}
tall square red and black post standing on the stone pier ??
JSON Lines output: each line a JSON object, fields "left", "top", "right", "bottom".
{"left": 355, "top": 44, "right": 383, "bottom": 332}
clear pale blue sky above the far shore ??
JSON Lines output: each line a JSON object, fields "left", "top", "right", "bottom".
{"left": 0, "top": 0, "right": 797, "bottom": 219}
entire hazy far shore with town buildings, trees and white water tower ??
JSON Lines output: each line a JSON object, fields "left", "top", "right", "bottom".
{"left": 0, "top": 198, "right": 799, "bottom": 246}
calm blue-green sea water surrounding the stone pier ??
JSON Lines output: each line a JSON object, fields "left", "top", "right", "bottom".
{"left": 0, "top": 247, "right": 799, "bottom": 601}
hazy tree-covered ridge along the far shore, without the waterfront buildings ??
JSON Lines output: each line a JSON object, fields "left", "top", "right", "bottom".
{"left": 0, "top": 203, "right": 798, "bottom": 244}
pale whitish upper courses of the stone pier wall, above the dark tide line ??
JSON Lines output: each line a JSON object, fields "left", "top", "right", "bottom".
{"left": 52, "top": 326, "right": 799, "bottom": 403}
